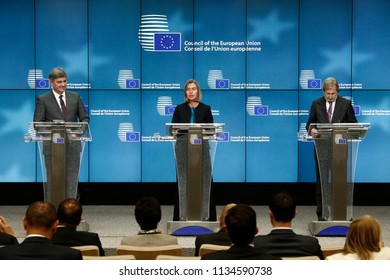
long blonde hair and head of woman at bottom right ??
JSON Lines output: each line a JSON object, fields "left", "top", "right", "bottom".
{"left": 343, "top": 215, "right": 382, "bottom": 260}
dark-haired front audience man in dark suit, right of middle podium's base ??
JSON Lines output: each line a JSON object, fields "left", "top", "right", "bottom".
{"left": 201, "top": 204, "right": 281, "bottom": 260}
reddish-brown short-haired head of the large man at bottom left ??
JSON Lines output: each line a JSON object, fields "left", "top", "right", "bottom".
{"left": 23, "top": 201, "right": 58, "bottom": 239}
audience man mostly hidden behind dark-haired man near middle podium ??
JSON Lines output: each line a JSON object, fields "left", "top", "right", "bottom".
{"left": 195, "top": 203, "right": 237, "bottom": 256}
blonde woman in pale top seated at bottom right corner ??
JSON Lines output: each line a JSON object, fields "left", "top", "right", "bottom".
{"left": 326, "top": 215, "right": 390, "bottom": 260}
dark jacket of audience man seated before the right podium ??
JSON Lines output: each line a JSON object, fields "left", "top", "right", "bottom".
{"left": 254, "top": 229, "right": 324, "bottom": 260}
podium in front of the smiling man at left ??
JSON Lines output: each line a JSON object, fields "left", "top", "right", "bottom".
{"left": 25, "top": 120, "right": 92, "bottom": 207}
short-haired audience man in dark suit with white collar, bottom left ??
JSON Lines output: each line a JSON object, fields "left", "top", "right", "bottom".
{"left": 0, "top": 201, "right": 83, "bottom": 260}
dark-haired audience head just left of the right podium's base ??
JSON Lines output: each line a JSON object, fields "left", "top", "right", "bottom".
{"left": 269, "top": 192, "right": 297, "bottom": 226}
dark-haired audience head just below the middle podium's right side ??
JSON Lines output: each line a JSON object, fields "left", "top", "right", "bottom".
{"left": 225, "top": 204, "right": 258, "bottom": 246}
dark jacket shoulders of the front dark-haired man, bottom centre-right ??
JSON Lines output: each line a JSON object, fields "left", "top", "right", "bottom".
{"left": 201, "top": 245, "right": 282, "bottom": 260}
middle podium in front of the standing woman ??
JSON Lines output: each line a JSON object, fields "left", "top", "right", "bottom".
{"left": 166, "top": 123, "right": 224, "bottom": 235}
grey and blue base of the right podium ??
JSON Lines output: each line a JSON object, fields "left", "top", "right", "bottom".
{"left": 309, "top": 221, "right": 351, "bottom": 236}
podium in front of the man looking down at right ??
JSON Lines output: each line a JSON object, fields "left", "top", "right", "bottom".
{"left": 309, "top": 123, "right": 370, "bottom": 236}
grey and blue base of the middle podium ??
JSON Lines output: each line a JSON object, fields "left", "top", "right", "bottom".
{"left": 167, "top": 221, "right": 220, "bottom": 236}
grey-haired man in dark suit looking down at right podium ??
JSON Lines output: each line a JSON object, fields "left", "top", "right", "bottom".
{"left": 306, "top": 77, "right": 358, "bottom": 221}
